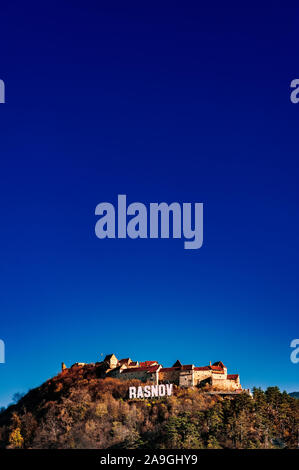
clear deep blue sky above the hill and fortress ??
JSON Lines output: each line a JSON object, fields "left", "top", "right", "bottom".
{"left": 0, "top": 1, "right": 299, "bottom": 405}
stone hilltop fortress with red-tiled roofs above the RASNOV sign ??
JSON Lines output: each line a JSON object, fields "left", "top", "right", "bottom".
{"left": 62, "top": 354, "right": 243, "bottom": 393}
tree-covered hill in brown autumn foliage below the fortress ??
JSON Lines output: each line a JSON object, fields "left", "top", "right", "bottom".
{"left": 0, "top": 364, "right": 299, "bottom": 449}
